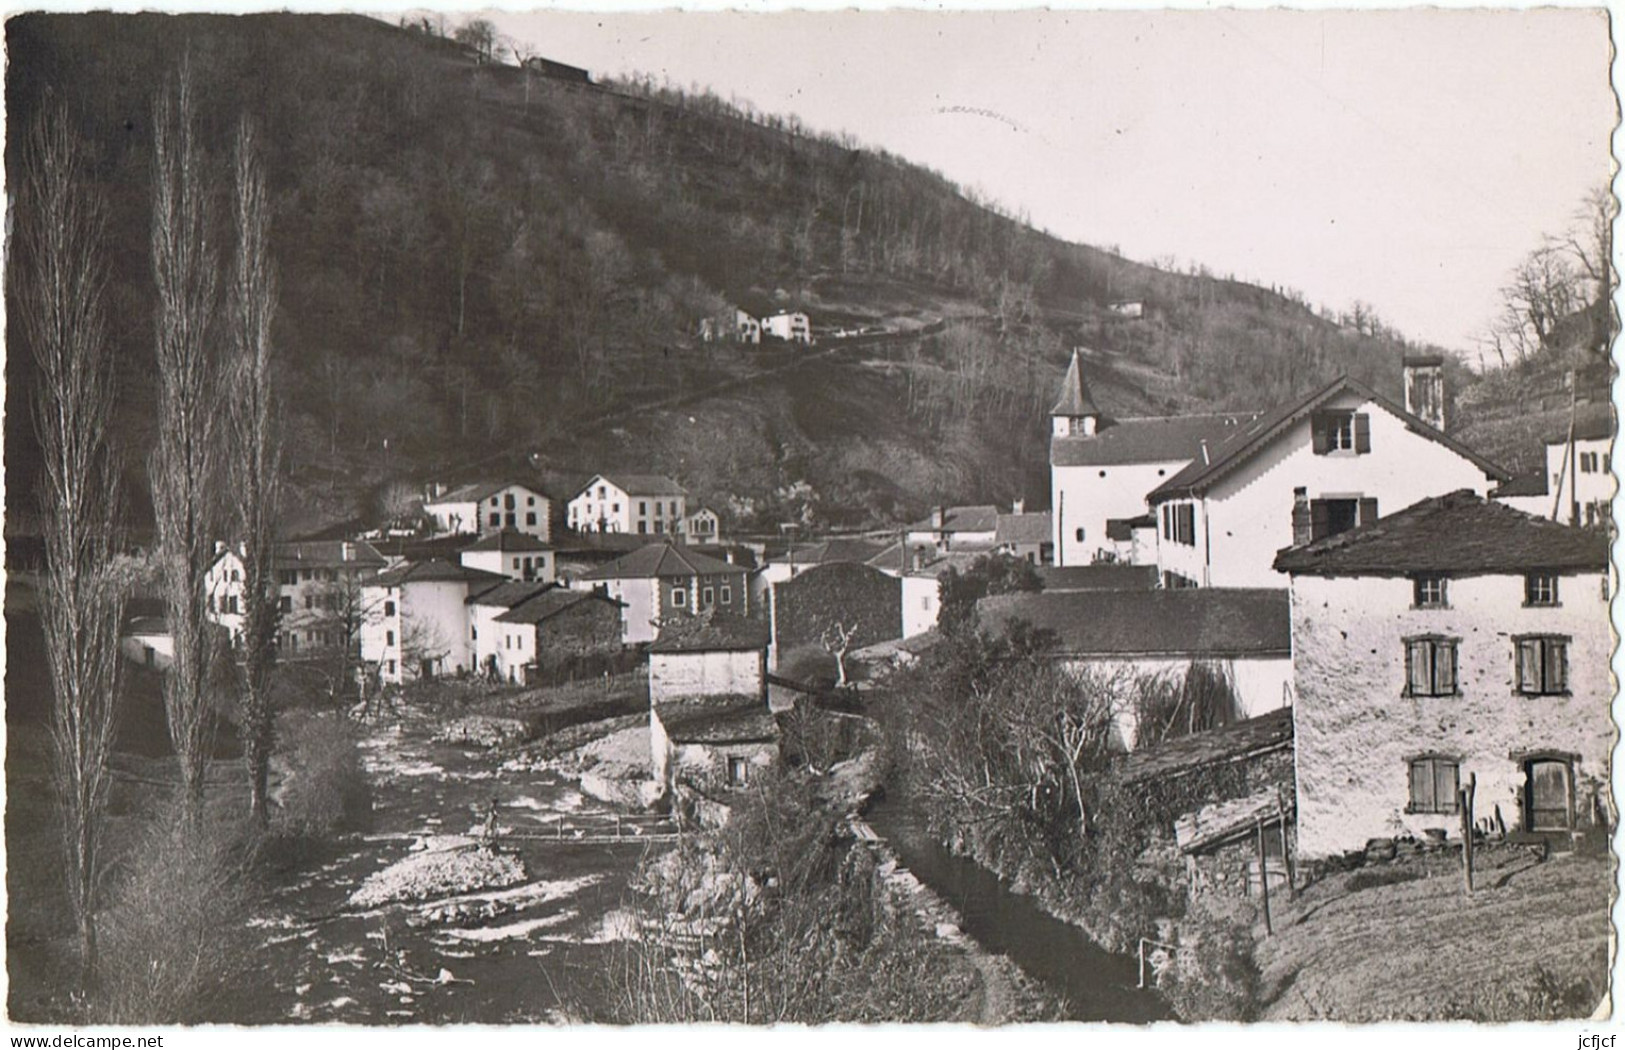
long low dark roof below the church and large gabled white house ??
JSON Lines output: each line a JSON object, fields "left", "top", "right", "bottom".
{"left": 977, "top": 587, "right": 1292, "bottom": 658}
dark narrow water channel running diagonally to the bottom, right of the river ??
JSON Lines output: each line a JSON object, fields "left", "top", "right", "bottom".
{"left": 865, "top": 798, "right": 1168, "bottom": 1024}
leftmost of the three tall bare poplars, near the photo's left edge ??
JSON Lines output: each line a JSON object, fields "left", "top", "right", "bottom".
{"left": 18, "top": 109, "right": 124, "bottom": 985}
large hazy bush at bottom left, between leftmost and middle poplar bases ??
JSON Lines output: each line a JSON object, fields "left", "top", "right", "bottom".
{"left": 88, "top": 806, "right": 252, "bottom": 1024}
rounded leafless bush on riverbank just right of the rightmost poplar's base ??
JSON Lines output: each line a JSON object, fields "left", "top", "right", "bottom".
{"left": 276, "top": 710, "right": 372, "bottom": 839}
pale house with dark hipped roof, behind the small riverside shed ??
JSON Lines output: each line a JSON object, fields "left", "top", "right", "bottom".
{"left": 570, "top": 541, "right": 751, "bottom": 645}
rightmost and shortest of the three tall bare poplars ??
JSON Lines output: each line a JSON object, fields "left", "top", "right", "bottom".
{"left": 226, "top": 119, "right": 281, "bottom": 826}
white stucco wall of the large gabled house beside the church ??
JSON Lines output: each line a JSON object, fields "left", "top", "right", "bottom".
{"left": 1157, "top": 395, "right": 1495, "bottom": 587}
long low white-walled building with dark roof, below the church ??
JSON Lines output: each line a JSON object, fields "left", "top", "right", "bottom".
{"left": 977, "top": 588, "right": 1292, "bottom": 749}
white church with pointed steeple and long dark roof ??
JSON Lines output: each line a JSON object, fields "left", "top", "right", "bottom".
{"left": 1050, "top": 349, "right": 1256, "bottom": 566}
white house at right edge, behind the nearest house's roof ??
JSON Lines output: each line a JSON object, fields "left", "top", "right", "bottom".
{"left": 1492, "top": 401, "right": 1614, "bottom": 528}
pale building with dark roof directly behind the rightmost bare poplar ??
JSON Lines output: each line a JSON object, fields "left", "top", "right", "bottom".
{"left": 203, "top": 540, "right": 388, "bottom": 658}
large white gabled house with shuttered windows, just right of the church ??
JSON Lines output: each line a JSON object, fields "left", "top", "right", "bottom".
{"left": 1147, "top": 368, "right": 1506, "bottom": 587}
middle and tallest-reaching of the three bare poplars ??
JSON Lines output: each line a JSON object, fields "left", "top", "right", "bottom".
{"left": 150, "top": 67, "right": 219, "bottom": 814}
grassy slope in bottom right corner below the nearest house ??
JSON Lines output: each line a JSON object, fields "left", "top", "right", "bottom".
{"left": 1258, "top": 848, "right": 1614, "bottom": 1021}
